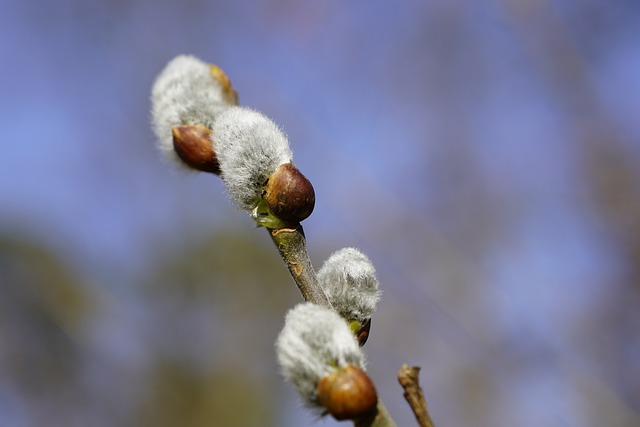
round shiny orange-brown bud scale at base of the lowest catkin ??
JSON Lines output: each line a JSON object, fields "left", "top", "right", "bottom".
{"left": 316, "top": 365, "right": 378, "bottom": 420}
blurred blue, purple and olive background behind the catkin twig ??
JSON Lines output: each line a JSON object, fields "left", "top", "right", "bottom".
{"left": 0, "top": 0, "right": 640, "bottom": 427}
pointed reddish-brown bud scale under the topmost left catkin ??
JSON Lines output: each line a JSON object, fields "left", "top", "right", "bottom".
{"left": 171, "top": 125, "right": 220, "bottom": 175}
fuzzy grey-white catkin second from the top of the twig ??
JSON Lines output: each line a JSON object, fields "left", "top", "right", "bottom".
{"left": 212, "top": 107, "right": 293, "bottom": 210}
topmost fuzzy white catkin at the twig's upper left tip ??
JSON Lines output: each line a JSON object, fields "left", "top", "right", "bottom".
{"left": 151, "top": 55, "right": 229, "bottom": 169}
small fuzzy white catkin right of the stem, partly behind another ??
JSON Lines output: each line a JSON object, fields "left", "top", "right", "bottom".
{"left": 318, "top": 248, "right": 380, "bottom": 322}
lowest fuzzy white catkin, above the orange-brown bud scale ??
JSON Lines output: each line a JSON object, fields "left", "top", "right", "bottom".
{"left": 276, "top": 302, "right": 365, "bottom": 408}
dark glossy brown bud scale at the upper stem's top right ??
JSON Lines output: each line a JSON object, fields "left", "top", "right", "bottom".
{"left": 265, "top": 163, "right": 316, "bottom": 223}
